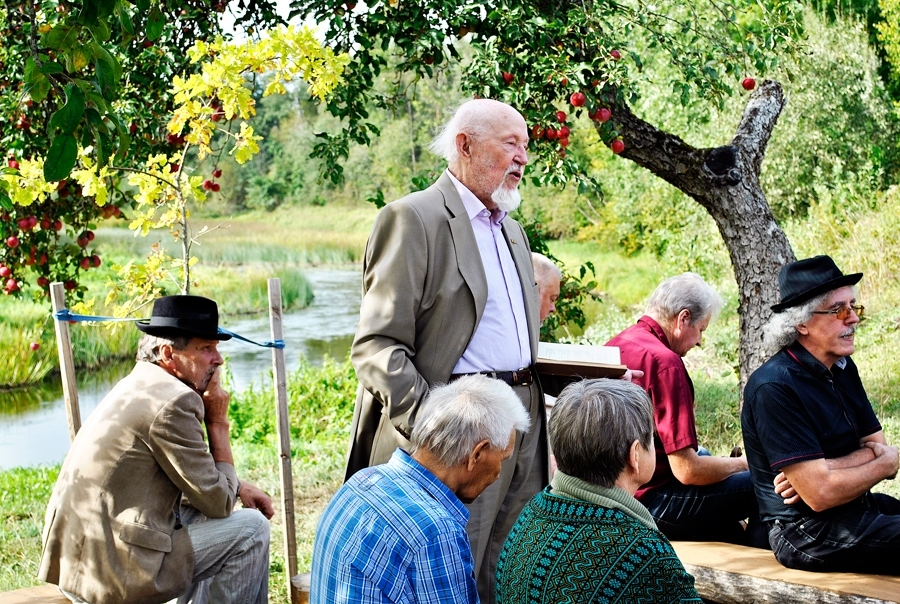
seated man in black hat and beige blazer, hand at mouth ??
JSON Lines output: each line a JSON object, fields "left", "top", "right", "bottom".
{"left": 39, "top": 296, "right": 274, "bottom": 604}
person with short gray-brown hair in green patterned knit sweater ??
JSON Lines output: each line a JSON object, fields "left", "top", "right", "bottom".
{"left": 497, "top": 379, "right": 701, "bottom": 604}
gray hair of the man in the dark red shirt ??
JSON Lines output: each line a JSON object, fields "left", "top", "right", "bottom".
{"left": 646, "top": 273, "right": 724, "bottom": 325}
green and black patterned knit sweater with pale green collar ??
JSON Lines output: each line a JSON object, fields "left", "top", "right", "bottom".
{"left": 497, "top": 472, "right": 701, "bottom": 604}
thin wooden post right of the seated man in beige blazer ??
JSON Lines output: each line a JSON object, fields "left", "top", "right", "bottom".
{"left": 269, "top": 279, "right": 297, "bottom": 602}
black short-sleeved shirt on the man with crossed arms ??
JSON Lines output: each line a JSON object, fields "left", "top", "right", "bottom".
{"left": 741, "top": 343, "right": 881, "bottom": 521}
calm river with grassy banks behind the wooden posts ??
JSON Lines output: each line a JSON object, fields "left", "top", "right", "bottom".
{"left": 0, "top": 269, "right": 361, "bottom": 470}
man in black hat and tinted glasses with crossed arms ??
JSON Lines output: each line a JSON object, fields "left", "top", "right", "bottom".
{"left": 741, "top": 256, "right": 900, "bottom": 575}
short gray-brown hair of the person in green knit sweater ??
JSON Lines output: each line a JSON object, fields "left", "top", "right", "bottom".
{"left": 549, "top": 379, "right": 653, "bottom": 488}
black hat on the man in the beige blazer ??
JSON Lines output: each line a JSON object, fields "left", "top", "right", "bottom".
{"left": 137, "top": 296, "right": 231, "bottom": 340}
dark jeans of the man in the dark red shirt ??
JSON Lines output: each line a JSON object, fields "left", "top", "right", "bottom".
{"left": 641, "top": 452, "right": 769, "bottom": 549}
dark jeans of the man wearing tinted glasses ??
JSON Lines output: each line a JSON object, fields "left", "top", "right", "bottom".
{"left": 769, "top": 493, "right": 900, "bottom": 575}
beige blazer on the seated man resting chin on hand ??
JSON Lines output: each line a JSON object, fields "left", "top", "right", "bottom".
{"left": 38, "top": 363, "right": 237, "bottom": 604}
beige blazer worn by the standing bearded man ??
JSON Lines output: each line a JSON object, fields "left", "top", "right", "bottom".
{"left": 346, "top": 172, "right": 540, "bottom": 478}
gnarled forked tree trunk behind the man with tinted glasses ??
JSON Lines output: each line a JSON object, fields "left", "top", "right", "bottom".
{"left": 613, "top": 80, "right": 796, "bottom": 400}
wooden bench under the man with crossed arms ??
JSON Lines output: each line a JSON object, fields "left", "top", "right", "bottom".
{"left": 672, "top": 541, "right": 900, "bottom": 604}
